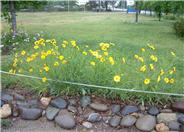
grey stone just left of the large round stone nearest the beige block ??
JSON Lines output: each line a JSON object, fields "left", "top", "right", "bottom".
{"left": 120, "top": 115, "right": 136, "bottom": 127}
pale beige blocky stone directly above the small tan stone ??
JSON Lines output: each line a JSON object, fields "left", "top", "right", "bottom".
{"left": 157, "top": 113, "right": 177, "bottom": 123}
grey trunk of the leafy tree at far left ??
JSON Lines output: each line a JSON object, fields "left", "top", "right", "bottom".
{"left": 10, "top": 1, "right": 16, "bottom": 37}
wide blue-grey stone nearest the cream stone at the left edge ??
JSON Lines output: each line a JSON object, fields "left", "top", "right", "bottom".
{"left": 20, "top": 107, "right": 42, "bottom": 120}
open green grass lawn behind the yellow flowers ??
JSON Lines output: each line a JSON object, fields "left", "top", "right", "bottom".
{"left": 3, "top": 12, "right": 184, "bottom": 102}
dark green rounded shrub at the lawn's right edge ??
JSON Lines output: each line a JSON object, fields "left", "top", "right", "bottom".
{"left": 174, "top": 18, "right": 184, "bottom": 37}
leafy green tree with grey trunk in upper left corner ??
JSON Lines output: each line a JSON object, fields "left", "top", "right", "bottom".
{"left": 1, "top": 1, "right": 47, "bottom": 37}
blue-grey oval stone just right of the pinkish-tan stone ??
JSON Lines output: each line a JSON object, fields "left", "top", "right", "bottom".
{"left": 50, "top": 97, "right": 67, "bottom": 109}
